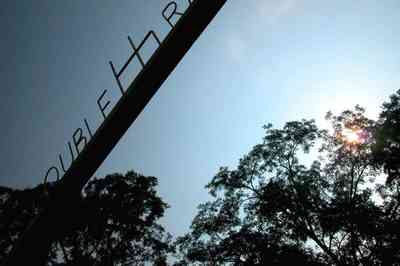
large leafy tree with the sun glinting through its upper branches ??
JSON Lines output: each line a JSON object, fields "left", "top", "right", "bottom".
{"left": 176, "top": 106, "right": 400, "bottom": 265}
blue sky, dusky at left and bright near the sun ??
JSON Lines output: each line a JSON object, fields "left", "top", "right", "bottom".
{"left": 0, "top": 0, "right": 400, "bottom": 236}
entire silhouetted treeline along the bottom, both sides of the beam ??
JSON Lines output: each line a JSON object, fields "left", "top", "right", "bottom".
{"left": 0, "top": 90, "right": 400, "bottom": 265}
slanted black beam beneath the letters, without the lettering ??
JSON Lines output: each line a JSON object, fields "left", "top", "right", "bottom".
{"left": 6, "top": 0, "right": 226, "bottom": 266}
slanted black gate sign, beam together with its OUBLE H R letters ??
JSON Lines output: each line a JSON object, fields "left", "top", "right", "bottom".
{"left": 6, "top": 0, "right": 226, "bottom": 266}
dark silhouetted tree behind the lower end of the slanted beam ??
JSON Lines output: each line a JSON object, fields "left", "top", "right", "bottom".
{"left": 0, "top": 171, "right": 173, "bottom": 266}
